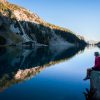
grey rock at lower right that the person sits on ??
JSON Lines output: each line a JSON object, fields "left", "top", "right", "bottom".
{"left": 83, "top": 71, "right": 100, "bottom": 100}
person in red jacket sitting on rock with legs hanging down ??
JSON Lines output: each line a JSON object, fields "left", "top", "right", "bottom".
{"left": 83, "top": 52, "right": 100, "bottom": 80}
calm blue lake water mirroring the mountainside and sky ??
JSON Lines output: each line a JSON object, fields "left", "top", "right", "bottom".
{"left": 0, "top": 47, "right": 100, "bottom": 100}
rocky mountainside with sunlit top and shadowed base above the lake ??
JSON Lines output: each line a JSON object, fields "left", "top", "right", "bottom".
{"left": 0, "top": 0, "right": 86, "bottom": 46}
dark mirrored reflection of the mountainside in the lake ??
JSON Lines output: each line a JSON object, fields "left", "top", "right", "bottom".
{"left": 0, "top": 47, "right": 84, "bottom": 91}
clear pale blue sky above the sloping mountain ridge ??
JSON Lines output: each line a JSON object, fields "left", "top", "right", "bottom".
{"left": 8, "top": 0, "right": 100, "bottom": 40}
